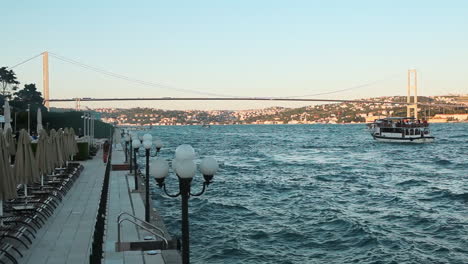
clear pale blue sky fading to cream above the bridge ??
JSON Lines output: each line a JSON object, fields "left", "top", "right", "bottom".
{"left": 0, "top": 0, "right": 468, "bottom": 110}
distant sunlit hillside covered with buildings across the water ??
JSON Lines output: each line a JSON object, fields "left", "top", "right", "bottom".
{"left": 96, "top": 96, "right": 467, "bottom": 125}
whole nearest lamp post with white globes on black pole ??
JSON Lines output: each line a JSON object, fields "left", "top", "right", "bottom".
{"left": 152, "top": 145, "right": 219, "bottom": 264}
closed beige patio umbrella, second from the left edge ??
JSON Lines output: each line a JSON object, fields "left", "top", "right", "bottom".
{"left": 14, "top": 129, "right": 39, "bottom": 196}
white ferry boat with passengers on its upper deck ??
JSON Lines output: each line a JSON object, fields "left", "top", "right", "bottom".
{"left": 367, "top": 117, "right": 434, "bottom": 143}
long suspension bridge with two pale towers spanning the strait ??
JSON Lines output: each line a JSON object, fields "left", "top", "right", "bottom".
{"left": 5, "top": 51, "right": 468, "bottom": 117}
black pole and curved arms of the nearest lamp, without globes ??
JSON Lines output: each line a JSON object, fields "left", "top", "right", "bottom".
{"left": 156, "top": 175, "right": 213, "bottom": 264}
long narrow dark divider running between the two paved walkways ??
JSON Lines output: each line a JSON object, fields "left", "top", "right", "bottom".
{"left": 89, "top": 136, "right": 113, "bottom": 264}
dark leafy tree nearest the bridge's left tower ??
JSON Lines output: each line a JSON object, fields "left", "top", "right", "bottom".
{"left": 11, "top": 83, "right": 47, "bottom": 112}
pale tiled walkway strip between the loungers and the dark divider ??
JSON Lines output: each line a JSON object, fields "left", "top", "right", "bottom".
{"left": 19, "top": 152, "right": 105, "bottom": 264}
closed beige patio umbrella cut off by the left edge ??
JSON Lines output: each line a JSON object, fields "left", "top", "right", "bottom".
{"left": 0, "top": 128, "right": 16, "bottom": 225}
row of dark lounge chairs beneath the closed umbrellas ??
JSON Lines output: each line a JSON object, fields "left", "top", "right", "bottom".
{"left": 0, "top": 162, "right": 83, "bottom": 264}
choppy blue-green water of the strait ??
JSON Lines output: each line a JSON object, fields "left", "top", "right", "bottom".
{"left": 144, "top": 124, "right": 468, "bottom": 264}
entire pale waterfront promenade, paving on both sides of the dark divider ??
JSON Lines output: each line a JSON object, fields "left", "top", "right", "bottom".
{"left": 19, "top": 150, "right": 181, "bottom": 264}
